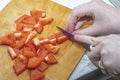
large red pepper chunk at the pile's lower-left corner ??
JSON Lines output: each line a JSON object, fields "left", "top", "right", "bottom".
{"left": 13, "top": 57, "right": 27, "bottom": 75}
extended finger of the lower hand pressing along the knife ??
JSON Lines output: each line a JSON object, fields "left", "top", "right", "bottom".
{"left": 74, "top": 35, "right": 106, "bottom": 46}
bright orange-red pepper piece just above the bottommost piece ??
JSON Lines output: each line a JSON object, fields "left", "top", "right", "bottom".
{"left": 28, "top": 56, "right": 42, "bottom": 68}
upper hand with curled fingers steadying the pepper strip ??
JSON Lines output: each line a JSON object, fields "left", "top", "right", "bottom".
{"left": 66, "top": 0, "right": 120, "bottom": 35}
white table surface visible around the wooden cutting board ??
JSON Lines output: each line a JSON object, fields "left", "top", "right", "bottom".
{"left": 0, "top": 0, "right": 113, "bottom": 80}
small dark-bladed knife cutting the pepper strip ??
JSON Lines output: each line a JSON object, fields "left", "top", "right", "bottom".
{"left": 56, "top": 26, "right": 91, "bottom": 51}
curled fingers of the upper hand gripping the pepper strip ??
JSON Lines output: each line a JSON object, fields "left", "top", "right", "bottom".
{"left": 66, "top": 5, "right": 93, "bottom": 32}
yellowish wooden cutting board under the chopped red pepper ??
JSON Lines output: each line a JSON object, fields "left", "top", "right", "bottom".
{"left": 0, "top": 0, "right": 88, "bottom": 80}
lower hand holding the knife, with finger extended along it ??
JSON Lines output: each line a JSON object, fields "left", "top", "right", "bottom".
{"left": 75, "top": 35, "right": 120, "bottom": 80}
